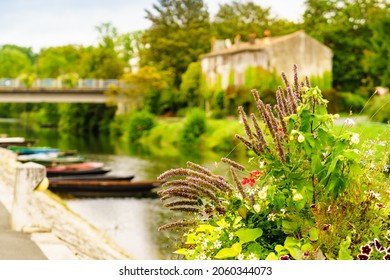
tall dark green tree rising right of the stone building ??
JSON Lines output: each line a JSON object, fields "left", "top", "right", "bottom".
{"left": 303, "top": 0, "right": 384, "bottom": 91}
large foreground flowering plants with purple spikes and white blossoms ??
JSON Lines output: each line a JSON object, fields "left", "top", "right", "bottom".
{"left": 158, "top": 65, "right": 390, "bottom": 260}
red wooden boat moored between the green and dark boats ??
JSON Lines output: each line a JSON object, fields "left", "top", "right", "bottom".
{"left": 46, "top": 162, "right": 110, "bottom": 177}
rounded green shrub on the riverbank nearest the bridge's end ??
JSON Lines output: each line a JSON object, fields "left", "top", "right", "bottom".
{"left": 127, "top": 111, "right": 155, "bottom": 142}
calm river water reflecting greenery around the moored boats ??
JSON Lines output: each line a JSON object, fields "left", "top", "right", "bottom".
{"left": 0, "top": 120, "right": 232, "bottom": 260}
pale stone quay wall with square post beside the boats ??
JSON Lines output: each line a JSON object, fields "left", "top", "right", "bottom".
{"left": 0, "top": 148, "right": 133, "bottom": 260}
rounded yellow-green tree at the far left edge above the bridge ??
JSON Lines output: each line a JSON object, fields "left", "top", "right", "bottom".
{"left": 0, "top": 45, "right": 32, "bottom": 78}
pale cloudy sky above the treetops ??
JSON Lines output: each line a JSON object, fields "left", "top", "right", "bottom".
{"left": 0, "top": 0, "right": 304, "bottom": 52}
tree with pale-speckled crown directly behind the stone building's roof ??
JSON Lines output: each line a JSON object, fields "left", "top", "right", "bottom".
{"left": 212, "top": 1, "right": 299, "bottom": 41}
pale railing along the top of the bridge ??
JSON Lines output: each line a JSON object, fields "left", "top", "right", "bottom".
{"left": 0, "top": 78, "right": 124, "bottom": 89}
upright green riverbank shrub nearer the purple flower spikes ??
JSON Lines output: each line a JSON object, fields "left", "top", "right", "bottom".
{"left": 179, "top": 108, "right": 206, "bottom": 148}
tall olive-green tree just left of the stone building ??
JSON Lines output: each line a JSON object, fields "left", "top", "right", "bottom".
{"left": 141, "top": 0, "right": 210, "bottom": 88}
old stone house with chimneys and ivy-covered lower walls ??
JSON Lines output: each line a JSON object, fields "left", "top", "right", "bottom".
{"left": 200, "top": 31, "right": 333, "bottom": 89}
